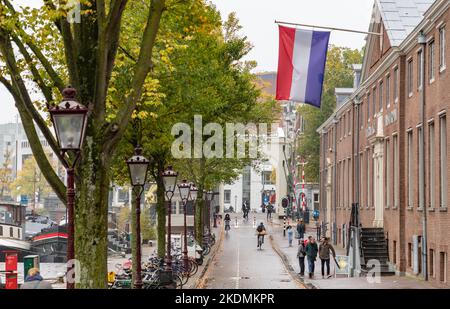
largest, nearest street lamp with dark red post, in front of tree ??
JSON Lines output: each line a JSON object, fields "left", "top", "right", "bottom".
{"left": 49, "top": 86, "right": 88, "bottom": 289}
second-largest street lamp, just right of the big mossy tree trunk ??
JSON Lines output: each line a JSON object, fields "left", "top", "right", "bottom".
{"left": 127, "top": 146, "right": 150, "bottom": 289}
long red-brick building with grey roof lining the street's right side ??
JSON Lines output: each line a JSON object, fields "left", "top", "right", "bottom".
{"left": 318, "top": 0, "right": 450, "bottom": 287}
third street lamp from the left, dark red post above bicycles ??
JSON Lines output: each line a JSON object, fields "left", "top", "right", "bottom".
{"left": 162, "top": 166, "right": 178, "bottom": 272}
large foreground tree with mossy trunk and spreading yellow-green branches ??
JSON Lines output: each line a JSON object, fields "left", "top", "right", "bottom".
{"left": 0, "top": 0, "right": 167, "bottom": 288}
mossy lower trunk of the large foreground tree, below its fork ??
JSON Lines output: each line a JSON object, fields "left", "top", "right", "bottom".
{"left": 75, "top": 136, "right": 111, "bottom": 289}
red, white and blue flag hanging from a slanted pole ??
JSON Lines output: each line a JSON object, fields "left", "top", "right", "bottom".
{"left": 276, "top": 26, "right": 330, "bottom": 107}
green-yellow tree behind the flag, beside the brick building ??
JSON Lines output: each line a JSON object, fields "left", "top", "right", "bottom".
{"left": 297, "top": 46, "right": 362, "bottom": 182}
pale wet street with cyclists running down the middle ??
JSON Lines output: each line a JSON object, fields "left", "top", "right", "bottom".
{"left": 205, "top": 214, "right": 300, "bottom": 289}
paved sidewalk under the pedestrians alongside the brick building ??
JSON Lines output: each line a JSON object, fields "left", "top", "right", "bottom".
{"left": 268, "top": 218, "right": 434, "bottom": 289}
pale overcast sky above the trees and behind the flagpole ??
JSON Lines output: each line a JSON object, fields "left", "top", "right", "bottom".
{"left": 0, "top": 0, "right": 374, "bottom": 123}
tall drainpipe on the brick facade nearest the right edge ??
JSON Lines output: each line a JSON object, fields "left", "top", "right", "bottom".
{"left": 417, "top": 31, "right": 431, "bottom": 280}
